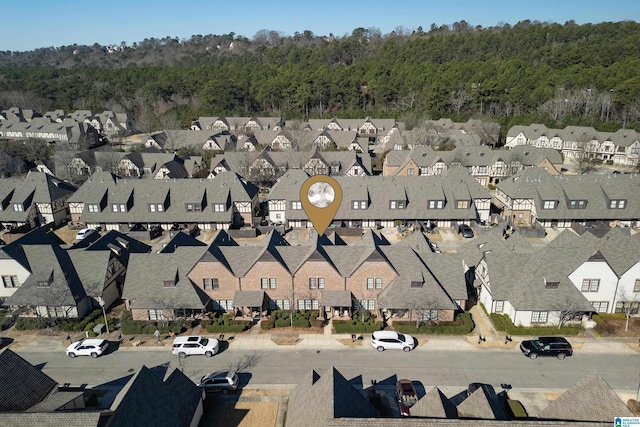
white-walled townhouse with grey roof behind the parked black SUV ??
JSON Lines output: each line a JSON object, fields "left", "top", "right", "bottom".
{"left": 460, "top": 230, "right": 640, "bottom": 326}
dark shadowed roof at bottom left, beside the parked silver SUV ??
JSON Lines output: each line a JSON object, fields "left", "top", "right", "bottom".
{"left": 109, "top": 366, "right": 202, "bottom": 427}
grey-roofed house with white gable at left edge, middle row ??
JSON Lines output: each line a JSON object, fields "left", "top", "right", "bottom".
{"left": 0, "top": 172, "right": 77, "bottom": 229}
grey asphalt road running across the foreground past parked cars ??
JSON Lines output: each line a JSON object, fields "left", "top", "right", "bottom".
{"left": 19, "top": 349, "right": 640, "bottom": 393}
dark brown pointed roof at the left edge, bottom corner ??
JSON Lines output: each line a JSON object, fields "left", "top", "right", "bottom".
{"left": 0, "top": 349, "right": 58, "bottom": 412}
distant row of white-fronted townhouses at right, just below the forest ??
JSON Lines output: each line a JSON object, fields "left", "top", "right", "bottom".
{"left": 505, "top": 123, "right": 640, "bottom": 166}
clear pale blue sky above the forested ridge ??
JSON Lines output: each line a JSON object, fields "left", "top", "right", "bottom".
{"left": 0, "top": 0, "right": 640, "bottom": 51}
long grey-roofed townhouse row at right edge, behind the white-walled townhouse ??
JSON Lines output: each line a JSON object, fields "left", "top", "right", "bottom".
{"left": 494, "top": 168, "right": 640, "bottom": 228}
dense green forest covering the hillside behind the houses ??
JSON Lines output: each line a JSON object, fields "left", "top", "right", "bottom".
{"left": 0, "top": 21, "right": 640, "bottom": 131}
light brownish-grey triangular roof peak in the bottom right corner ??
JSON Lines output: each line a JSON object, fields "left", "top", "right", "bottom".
{"left": 539, "top": 372, "right": 633, "bottom": 423}
